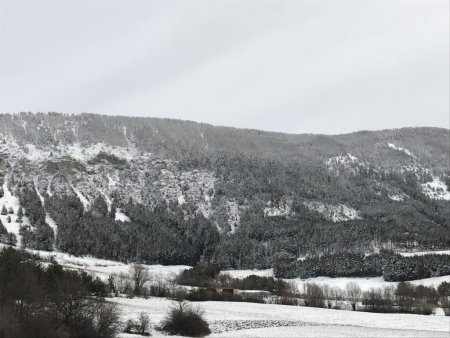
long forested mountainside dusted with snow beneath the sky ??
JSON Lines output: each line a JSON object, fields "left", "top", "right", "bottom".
{"left": 0, "top": 113, "right": 450, "bottom": 268}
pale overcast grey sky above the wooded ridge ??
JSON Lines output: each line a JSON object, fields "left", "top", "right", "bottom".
{"left": 0, "top": 0, "right": 449, "bottom": 134}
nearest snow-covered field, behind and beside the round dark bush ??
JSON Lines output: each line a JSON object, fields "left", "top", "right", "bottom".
{"left": 109, "top": 298, "right": 449, "bottom": 337}
